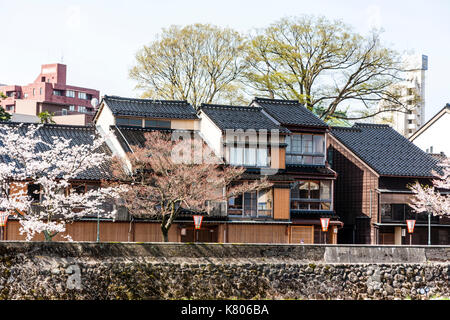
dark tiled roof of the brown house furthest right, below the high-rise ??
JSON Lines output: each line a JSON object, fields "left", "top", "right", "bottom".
{"left": 331, "top": 123, "right": 438, "bottom": 177}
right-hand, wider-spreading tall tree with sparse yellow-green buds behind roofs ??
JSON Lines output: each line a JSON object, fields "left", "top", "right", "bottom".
{"left": 245, "top": 16, "right": 407, "bottom": 120}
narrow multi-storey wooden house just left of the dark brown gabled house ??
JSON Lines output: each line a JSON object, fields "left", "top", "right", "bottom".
{"left": 251, "top": 98, "right": 343, "bottom": 243}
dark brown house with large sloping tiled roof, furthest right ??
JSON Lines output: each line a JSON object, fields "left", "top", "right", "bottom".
{"left": 327, "top": 123, "right": 450, "bottom": 245}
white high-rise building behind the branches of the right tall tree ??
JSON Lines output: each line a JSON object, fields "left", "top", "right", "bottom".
{"left": 374, "top": 55, "right": 428, "bottom": 138}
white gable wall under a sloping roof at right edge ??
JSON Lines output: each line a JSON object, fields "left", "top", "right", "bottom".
{"left": 413, "top": 112, "right": 450, "bottom": 157}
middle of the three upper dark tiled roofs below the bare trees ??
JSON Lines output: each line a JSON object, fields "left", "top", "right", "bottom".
{"left": 201, "top": 104, "right": 290, "bottom": 133}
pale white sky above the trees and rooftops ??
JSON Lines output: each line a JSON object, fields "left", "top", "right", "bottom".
{"left": 0, "top": 0, "right": 450, "bottom": 120}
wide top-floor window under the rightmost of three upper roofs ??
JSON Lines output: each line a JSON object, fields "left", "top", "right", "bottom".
{"left": 286, "top": 134, "right": 325, "bottom": 165}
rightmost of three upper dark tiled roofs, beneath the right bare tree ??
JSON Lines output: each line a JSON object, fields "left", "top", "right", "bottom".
{"left": 252, "top": 98, "right": 328, "bottom": 128}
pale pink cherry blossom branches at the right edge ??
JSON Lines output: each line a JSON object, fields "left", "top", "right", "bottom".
{"left": 410, "top": 158, "right": 450, "bottom": 216}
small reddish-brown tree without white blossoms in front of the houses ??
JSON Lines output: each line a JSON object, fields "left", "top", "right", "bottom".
{"left": 113, "top": 131, "right": 271, "bottom": 242}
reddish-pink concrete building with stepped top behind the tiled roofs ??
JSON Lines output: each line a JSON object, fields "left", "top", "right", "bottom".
{"left": 0, "top": 63, "right": 100, "bottom": 124}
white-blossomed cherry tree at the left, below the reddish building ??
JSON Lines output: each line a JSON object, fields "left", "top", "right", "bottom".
{"left": 0, "top": 125, "right": 121, "bottom": 241}
